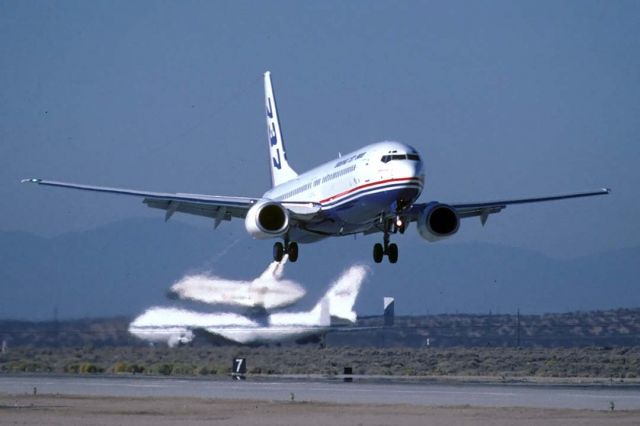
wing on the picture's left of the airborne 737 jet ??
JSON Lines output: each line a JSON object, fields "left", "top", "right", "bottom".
{"left": 22, "top": 179, "right": 315, "bottom": 228}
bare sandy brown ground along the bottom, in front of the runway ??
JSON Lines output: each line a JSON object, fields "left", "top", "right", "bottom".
{"left": 0, "top": 394, "right": 640, "bottom": 426}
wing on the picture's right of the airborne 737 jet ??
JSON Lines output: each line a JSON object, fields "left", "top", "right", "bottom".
{"left": 409, "top": 188, "right": 611, "bottom": 225}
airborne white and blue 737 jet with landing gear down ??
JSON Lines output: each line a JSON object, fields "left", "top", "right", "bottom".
{"left": 22, "top": 71, "right": 609, "bottom": 263}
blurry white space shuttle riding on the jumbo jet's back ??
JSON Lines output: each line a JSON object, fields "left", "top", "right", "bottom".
{"left": 168, "top": 256, "right": 306, "bottom": 310}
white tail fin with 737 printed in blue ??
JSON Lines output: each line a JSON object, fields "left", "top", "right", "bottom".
{"left": 264, "top": 71, "right": 298, "bottom": 186}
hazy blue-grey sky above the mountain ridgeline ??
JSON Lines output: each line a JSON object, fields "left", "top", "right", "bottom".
{"left": 0, "top": 0, "right": 640, "bottom": 257}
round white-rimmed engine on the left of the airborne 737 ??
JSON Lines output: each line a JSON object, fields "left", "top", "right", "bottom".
{"left": 244, "top": 201, "right": 289, "bottom": 239}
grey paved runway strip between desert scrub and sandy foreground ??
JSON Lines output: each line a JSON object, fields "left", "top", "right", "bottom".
{"left": 0, "top": 376, "right": 640, "bottom": 410}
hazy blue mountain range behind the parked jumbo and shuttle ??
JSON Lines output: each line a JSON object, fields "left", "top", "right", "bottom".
{"left": 0, "top": 218, "right": 640, "bottom": 320}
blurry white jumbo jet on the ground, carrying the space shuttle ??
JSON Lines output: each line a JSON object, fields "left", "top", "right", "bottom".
{"left": 129, "top": 265, "right": 367, "bottom": 347}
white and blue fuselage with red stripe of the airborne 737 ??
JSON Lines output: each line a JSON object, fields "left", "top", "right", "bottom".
{"left": 263, "top": 142, "right": 424, "bottom": 243}
